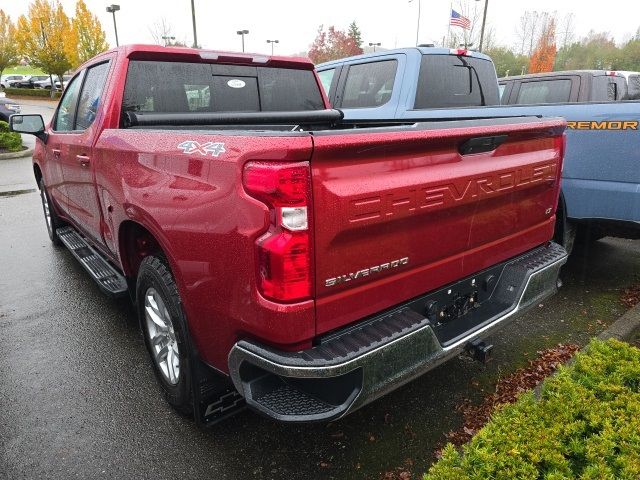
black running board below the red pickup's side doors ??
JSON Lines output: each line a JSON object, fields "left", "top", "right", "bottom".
{"left": 56, "top": 227, "right": 128, "bottom": 298}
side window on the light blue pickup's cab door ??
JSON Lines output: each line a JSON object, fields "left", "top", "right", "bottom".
{"left": 341, "top": 60, "right": 398, "bottom": 108}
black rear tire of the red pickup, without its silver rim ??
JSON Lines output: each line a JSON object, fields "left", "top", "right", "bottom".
{"left": 136, "top": 256, "right": 193, "bottom": 415}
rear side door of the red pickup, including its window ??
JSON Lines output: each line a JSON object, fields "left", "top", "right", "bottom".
{"left": 53, "top": 61, "right": 109, "bottom": 242}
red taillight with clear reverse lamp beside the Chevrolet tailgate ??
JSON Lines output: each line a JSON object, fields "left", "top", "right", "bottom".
{"left": 243, "top": 162, "right": 312, "bottom": 302}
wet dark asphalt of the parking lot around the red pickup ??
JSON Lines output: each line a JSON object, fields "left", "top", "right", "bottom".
{"left": 0, "top": 99, "right": 640, "bottom": 479}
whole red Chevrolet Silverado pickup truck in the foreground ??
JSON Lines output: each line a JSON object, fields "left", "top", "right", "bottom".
{"left": 10, "top": 45, "right": 566, "bottom": 424}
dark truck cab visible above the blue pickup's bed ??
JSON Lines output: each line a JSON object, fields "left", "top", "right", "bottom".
{"left": 499, "top": 70, "right": 627, "bottom": 105}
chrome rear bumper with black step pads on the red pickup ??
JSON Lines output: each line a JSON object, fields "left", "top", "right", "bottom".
{"left": 229, "top": 243, "right": 567, "bottom": 422}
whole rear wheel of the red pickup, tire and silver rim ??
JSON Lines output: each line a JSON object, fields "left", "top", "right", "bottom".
{"left": 136, "top": 256, "right": 193, "bottom": 414}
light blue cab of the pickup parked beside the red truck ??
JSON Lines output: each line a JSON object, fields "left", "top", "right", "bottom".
{"left": 316, "top": 47, "right": 500, "bottom": 119}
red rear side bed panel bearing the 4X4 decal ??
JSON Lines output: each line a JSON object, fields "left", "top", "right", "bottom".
{"left": 95, "top": 129, "right": 314, "bottom": 371}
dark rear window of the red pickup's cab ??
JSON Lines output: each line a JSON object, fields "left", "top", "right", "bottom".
{"left": 122, "top": 61, "right": 324, "bottom": 117}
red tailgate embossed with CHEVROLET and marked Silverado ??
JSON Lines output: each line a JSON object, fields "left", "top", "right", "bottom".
{"left": 311, "top": 118, "right": 564, "bottom": 334}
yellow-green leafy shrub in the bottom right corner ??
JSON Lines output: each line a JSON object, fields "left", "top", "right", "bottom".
{"left": 424, "top": 340, "right": 640, "bottom": 480}
